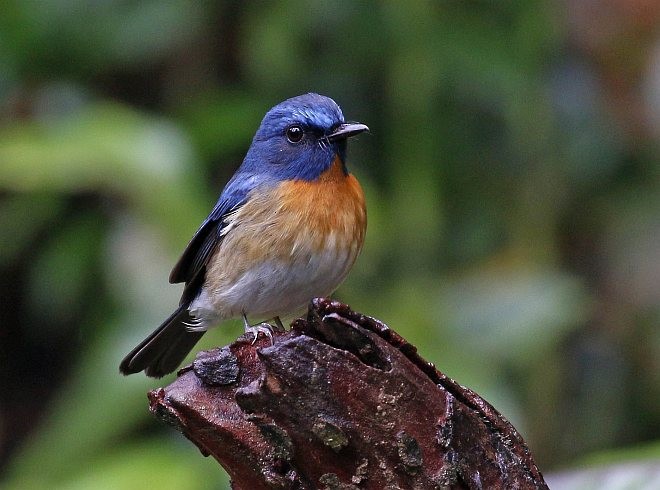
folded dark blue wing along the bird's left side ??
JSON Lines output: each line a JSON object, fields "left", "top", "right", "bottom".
{"left": 170, "top": 173, "right": 265, "bottom": 288}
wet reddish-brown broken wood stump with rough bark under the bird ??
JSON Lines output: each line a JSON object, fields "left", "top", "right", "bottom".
{"left": 149, "top": 299, "right": 547, "bottom": 490}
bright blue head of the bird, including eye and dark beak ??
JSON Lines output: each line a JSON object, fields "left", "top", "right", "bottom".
{"left": 239, "top": 93, "right": 368, "bottom": 180}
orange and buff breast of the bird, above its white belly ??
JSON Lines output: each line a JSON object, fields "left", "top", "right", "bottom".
{"left": 207, "top": 158, "right": 367, "bottom": 289}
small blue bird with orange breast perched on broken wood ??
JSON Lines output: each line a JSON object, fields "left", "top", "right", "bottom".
{"left": 119, "top": 93, "right": 369, "bottom": 378}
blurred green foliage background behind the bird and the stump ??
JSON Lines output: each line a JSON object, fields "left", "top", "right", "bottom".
{"left": 0, "top": 0, "right": 660, "bottom": 489}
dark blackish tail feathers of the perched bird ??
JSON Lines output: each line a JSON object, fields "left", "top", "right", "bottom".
{"left": 119, "top": 303, "right": 204, "bottom": 378}
